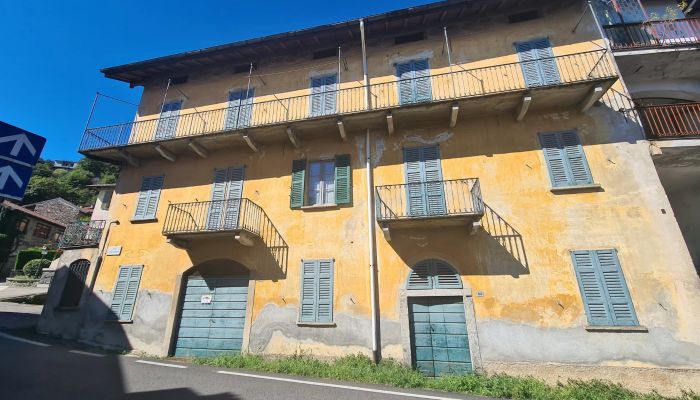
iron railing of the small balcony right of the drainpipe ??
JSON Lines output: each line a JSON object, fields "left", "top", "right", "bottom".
{"left": 376, "top": 178, "right": 484, "bottom": 222}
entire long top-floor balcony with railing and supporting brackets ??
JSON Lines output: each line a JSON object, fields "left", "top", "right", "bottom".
{"left": 80, "top": 50, "right": 617, "bottom": 161}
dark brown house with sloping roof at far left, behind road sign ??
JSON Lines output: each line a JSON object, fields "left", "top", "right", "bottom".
{"left": 0, "top": 200, "right": 66, "bottom": 277}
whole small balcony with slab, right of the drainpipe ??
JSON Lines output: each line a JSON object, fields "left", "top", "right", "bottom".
{"left": 375, "top": 178, "right": 484, "bottom": 240}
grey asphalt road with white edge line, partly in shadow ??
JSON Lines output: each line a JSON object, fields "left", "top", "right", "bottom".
{"left": 0, "top": 304, "right": 486, "bottom": 400}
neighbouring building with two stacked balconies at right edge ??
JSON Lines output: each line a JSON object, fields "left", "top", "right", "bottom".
{"left": 593, "top": 0, "right": 700, "bottom": 274}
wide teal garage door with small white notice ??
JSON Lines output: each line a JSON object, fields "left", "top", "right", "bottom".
{"left": 175, "top": 276, "right": 248, "bottom": 357}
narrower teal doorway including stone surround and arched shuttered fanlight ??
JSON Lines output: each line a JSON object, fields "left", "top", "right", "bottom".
{"left": 402, "top": 259, "right": 479, "bottom": 376}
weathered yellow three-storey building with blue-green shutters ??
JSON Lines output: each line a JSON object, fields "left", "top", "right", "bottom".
{"left": 45, "top": 0, "right": 700, "bottom": 392}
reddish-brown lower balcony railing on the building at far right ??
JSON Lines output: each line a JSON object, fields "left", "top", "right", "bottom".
{"left": 637, "top": 103, "right": 700, "bottom": 139}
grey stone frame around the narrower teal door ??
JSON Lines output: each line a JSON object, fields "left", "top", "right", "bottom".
{"left": 399, "top": 282, "right": 484, "bottom": 374}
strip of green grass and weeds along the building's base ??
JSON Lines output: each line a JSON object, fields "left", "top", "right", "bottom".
{"left": 194, "top": 355, "right": 700, "bottom": 400}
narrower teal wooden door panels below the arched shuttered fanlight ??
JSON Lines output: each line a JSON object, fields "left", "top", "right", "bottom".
{"left": 408, "top": 297, "right": 472, "bottom": 376}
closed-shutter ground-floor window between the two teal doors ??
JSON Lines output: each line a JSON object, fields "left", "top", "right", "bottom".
{"left": 299, "top": 259, "right": 335, "bottom": 323}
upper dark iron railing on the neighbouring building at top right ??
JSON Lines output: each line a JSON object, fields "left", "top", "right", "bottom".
{"left": 603, "top": 18, "right": 700, "bottom": 50}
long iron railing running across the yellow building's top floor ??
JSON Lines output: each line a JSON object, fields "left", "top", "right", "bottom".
{"left": 80, "top": 50, "right": 616, "bottom": 151}
